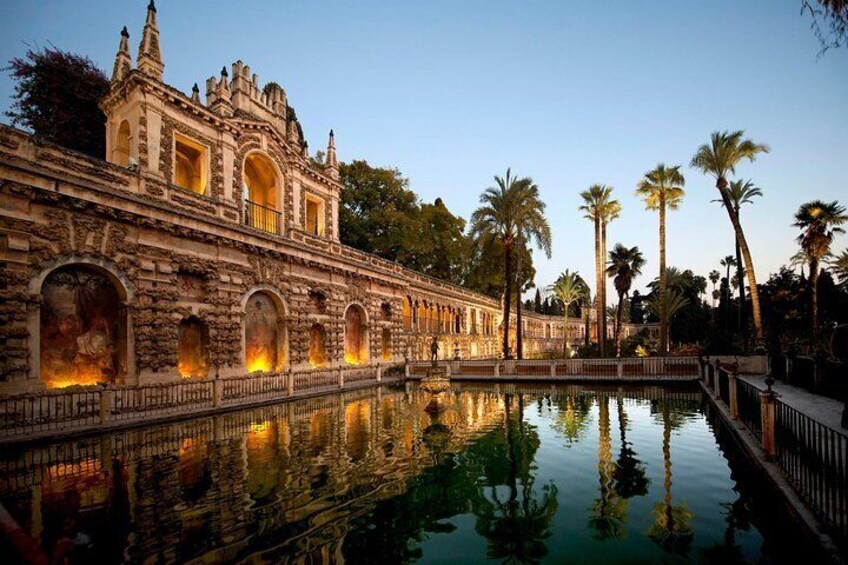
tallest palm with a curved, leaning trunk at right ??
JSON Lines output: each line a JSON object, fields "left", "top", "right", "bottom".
{"left": 690, "top": 130, "right": 769, "bottom": 342}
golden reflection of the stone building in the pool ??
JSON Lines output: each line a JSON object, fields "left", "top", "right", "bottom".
{"left": 0, "top": 388, "right": 504, "bottom": 562}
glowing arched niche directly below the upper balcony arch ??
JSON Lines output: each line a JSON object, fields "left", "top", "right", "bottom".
{"left": 244, "top": 292, "right": 286, "bottom": 373}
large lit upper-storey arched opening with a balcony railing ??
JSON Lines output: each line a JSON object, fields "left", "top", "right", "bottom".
{"left": 244, "top": 153, "right": 282, "bottom": 233}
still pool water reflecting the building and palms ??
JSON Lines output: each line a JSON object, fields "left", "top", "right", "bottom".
{"left": 0, "top": 384, "right": 820, "bottom": 563}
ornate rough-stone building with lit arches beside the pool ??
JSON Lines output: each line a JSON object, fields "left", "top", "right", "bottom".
{"left": 0, "top": 2, "right": 656, "bottom": 393}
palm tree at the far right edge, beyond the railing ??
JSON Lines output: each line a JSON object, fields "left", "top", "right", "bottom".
{"left": 795, "top": 200, "right": 848, "bottom": 345}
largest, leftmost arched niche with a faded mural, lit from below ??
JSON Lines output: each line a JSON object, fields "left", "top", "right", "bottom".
{"left": 40, "top": 265, "right": 127, "bottom": 388}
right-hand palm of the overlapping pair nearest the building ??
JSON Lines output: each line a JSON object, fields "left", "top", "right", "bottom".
{"left": 515, "top": 177, "right": 551, "bottom": 359}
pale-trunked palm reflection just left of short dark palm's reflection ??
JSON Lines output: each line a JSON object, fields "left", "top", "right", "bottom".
{"left": 589, "top": 396, "right": 628, "bottom": 540}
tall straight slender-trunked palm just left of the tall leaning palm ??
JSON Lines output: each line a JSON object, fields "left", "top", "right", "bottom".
{"left": 636, "top": 163, "right": 686, "bottom": 355}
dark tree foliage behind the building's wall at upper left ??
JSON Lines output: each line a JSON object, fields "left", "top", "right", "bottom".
{"left": 4, "top": 47, "right": 109, "bottom": 159}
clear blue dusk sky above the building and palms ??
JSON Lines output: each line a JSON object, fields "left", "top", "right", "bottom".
{"left": 0, "top": 0, "right": 848, "bottom": 300}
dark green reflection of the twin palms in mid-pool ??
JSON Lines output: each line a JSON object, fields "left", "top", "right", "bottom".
{"left": 477, "top": 394, "right": 557, "bottom": 563}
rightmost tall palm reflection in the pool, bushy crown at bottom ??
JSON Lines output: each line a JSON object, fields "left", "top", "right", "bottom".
{"left": 648, "top": 400, "right": 693, "bottom": 553}
